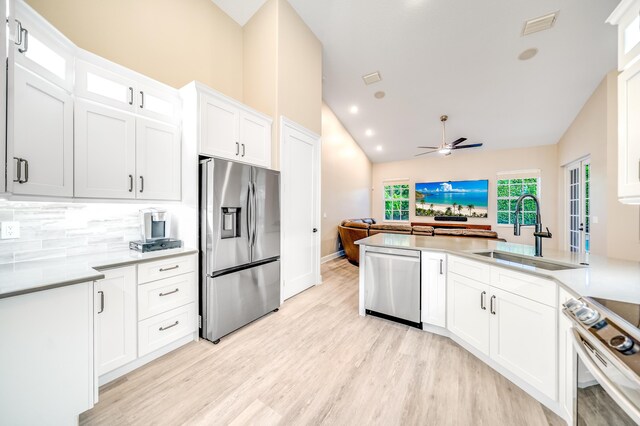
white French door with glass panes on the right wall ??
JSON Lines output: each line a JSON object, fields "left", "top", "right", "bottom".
{"left": 566, "top": 158, "right": 591, "bottom": 253}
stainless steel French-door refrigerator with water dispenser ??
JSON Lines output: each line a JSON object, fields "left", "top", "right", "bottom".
{"left": 200, "top": 158, "right": 280, "bottom": 343}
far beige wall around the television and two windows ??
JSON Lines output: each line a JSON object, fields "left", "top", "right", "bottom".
{"left": 371, "top": 145, "right": 558, "bottom": 247}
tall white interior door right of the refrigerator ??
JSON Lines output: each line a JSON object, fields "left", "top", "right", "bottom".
{"left": 280, "top": 118, "right": 320, "bottom": 299}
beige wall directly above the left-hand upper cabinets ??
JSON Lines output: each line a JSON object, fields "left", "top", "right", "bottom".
{"left": 27, "top": 0, "right": 243, "bottom": 100}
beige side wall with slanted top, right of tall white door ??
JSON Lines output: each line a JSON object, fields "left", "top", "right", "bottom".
{"left": 322, "top": 104, "right": 372, "bottom": 256}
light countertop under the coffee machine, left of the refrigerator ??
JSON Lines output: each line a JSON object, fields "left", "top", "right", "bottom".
{"left": 0, "top": 248, "right": 198, "bottom": 299}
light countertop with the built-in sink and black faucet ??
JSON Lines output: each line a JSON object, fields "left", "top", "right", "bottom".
{"left": 356, "top": 234, "right": 640, "bottom": 304}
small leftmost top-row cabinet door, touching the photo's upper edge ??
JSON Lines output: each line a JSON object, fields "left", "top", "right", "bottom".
{"left": 10, "top": 1, "right": 75, "bottom": 92}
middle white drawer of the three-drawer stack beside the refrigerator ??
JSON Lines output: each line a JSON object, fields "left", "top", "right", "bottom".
{"left": 138, "top": 272, "right": 196, "bottom": 320}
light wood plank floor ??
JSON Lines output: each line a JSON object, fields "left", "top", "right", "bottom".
{"left": 80, "top": 259, "right": 564, "bottom": 425}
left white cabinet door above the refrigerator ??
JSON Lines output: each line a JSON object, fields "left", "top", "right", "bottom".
{"left": 200, "top": 94, "right": 240, "bottom": 160}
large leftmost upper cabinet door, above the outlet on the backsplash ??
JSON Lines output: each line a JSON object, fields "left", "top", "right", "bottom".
{"left": 8, "top": 66, "right": 73, "bottom": 197}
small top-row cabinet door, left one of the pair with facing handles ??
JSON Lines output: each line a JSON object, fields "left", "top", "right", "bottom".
{"left": 75, "top": 59, "right": 136, "bottom": 112}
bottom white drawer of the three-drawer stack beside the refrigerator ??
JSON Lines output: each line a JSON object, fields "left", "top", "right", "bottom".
{"left": 138, "top": 303, "right": 197, "bottom": 356}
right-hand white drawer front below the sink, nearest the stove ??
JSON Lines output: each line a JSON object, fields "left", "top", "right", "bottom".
{"left": 491, "top": 266, "right": 558, "bottom": 307}
